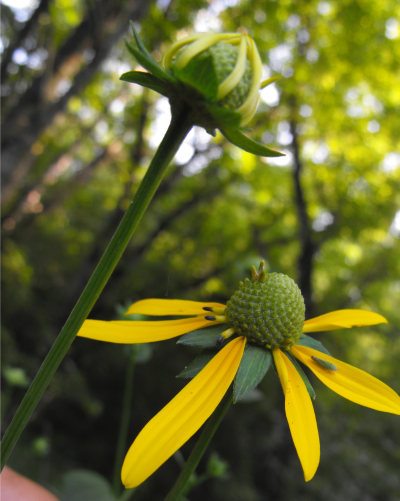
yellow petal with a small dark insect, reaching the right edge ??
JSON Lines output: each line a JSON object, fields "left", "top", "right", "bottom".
{"left": 290, "top": 345, "right": 400, "bottom": 414}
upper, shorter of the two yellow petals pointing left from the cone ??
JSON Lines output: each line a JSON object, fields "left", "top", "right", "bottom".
{"left": 125, "top": 299, "right": 226, "bottom": 316}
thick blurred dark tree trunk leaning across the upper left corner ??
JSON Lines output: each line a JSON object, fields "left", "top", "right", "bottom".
{"left": 2, "top": 0, "right": 155, "bottom": 199}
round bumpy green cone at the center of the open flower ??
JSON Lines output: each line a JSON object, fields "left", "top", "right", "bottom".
{"left": 226, "top": 272, "right": 305, "bottom": 349}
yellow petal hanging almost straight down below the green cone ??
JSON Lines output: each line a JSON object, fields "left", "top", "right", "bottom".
{"left": 272, "top": 348, "right": 320, "bottom": 482}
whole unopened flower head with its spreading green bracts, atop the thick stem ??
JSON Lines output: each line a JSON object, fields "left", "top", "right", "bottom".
{"left": 121, "top": 25, "right": 282, "bottom": 157}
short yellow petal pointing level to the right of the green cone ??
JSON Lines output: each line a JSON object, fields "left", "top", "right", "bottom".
{"left": 303, "top": 310, "right": 387, "bottom": 332}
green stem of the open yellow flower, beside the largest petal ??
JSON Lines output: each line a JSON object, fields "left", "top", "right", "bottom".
{"left": 164, "top": 386, "right": 233, "bottom": 501}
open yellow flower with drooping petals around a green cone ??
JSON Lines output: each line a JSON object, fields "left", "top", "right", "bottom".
{"left": 78, "top": 274, "right": 400, "bottom": 488}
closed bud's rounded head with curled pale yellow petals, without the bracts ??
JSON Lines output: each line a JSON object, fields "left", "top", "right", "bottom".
{"left": 164, "top": 33, "right": 262, "bottom": 125}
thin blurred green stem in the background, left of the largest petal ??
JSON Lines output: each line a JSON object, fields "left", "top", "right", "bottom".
{"left": 113, "top": 345, "right": 138, "bottom": 496}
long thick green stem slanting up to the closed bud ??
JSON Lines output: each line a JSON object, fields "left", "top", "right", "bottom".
{"left": 1, "top": 102, "right": 192, "bottom": 469}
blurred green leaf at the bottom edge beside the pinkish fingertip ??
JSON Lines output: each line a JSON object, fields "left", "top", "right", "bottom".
{"left": 62, "top": 470, "right": 116, "bottom": 501}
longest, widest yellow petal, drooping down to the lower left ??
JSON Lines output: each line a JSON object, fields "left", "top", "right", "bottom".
{"left": 121, "top": 337, "right": 246, "bottom": 489}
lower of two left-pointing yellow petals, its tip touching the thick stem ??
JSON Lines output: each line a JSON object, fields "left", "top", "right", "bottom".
{"left": 77, "top": 317, "right": 215, "bottom": 344}
